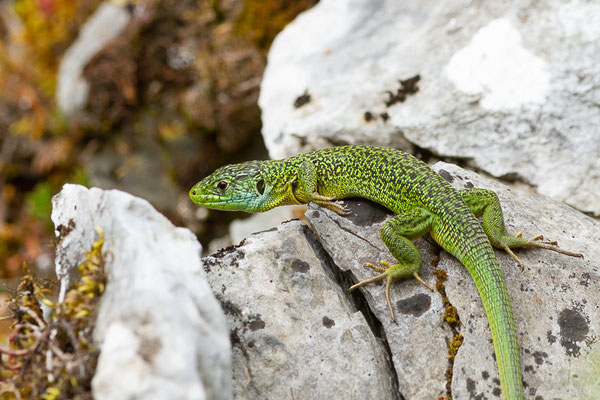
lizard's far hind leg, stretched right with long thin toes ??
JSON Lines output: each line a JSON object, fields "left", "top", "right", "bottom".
{"left": 458, "top": 188, "right": 583, "bottom": 270}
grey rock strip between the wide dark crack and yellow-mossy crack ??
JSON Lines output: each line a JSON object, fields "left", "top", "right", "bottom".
{"left": 306, "top": 199, "right": 448, "bottom": 399}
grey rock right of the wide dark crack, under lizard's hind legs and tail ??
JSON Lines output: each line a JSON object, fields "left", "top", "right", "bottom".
{"left": 306, "top": 163, "right": 600, "bottom": 399}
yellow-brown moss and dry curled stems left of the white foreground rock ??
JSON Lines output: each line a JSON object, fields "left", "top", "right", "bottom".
{"left": 0, "top": 228, "right": 106, "bottom": 400}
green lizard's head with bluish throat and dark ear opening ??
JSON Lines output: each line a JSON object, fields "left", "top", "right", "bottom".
{"left": 190, "top": 161, "right": 265, "bottom": 212}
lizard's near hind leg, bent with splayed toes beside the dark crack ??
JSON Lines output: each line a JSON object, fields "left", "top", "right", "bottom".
{"left": 349, "top": 208, "right": 433, "bottom": 321}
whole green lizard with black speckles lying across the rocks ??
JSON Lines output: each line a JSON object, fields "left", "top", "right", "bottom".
{"left": 190, "top": 146, "right": 581, "bottom": 400}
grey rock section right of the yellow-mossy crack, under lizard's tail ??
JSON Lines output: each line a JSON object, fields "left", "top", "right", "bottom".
{"left": 434, "top": 162, "right": 600, "bottom": 399}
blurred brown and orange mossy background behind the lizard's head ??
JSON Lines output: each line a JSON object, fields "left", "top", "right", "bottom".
{"left": 0, "top": 0, "right": 317, "bottom": 338}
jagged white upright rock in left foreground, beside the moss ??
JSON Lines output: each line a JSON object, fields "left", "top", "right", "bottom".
{"left": 52, "top": 185, "right": 231, "bottom": 399}
